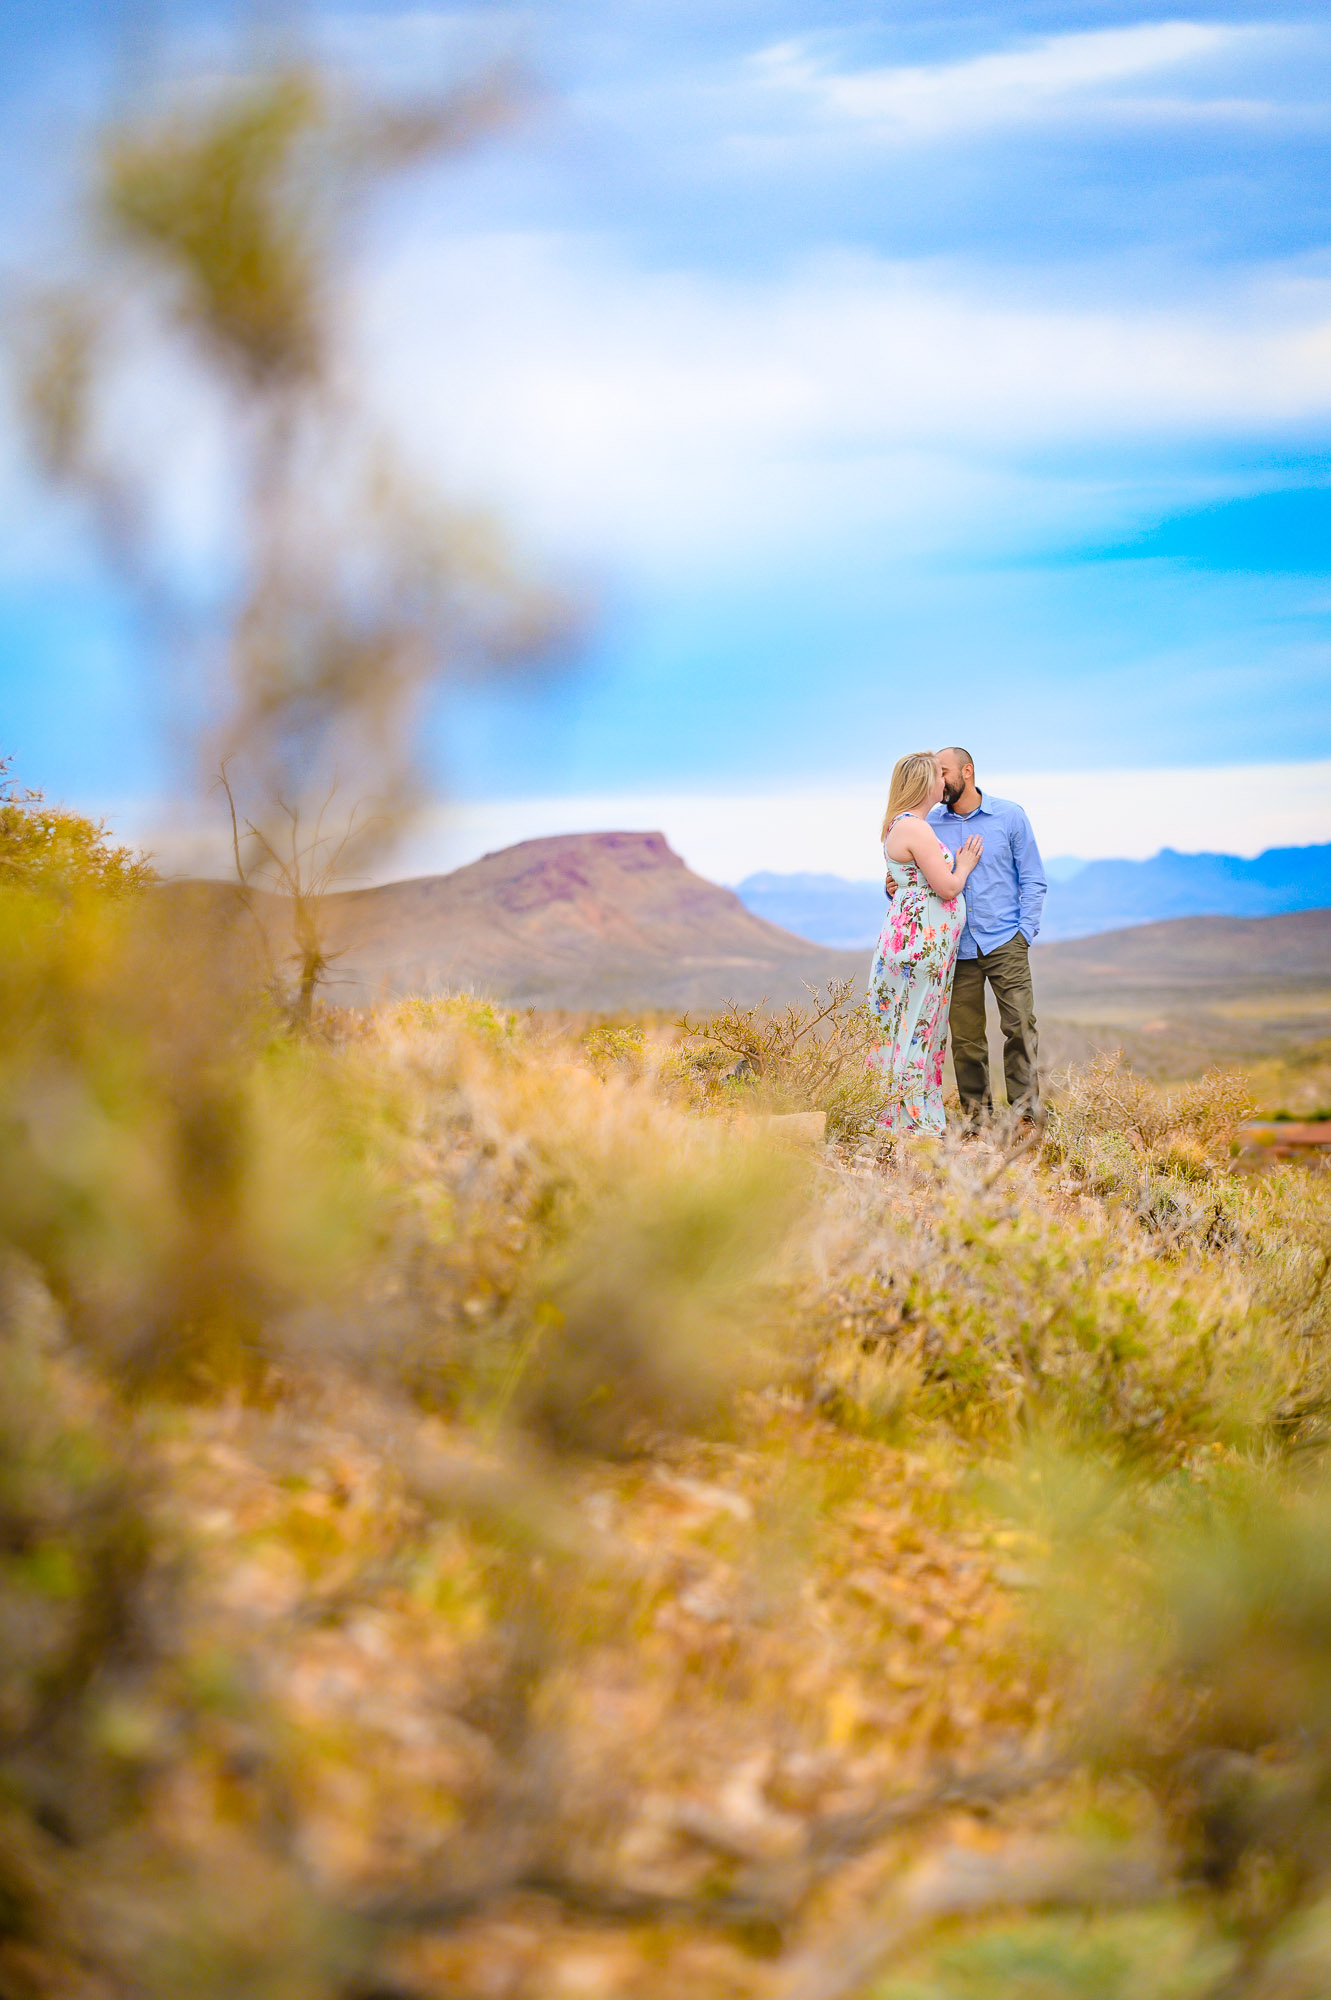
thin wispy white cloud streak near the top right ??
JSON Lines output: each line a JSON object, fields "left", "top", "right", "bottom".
{"left": 751, "top": 20, "right": 1261, "bottom": 140}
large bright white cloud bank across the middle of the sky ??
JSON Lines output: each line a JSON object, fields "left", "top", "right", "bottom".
{"left": 364, "top": 234, "right": 1331, "bottom": 574}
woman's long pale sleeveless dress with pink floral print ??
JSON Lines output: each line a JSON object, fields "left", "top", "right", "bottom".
{"left": 869, "top": 814, "right": 965, "bottom": 1132}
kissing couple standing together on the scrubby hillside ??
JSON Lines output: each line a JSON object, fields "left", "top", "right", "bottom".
{"left": 869, "top": 744, "right": 1047, "bottom": 1138}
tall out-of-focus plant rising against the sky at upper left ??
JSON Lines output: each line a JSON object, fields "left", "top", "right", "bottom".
{"left": 19, "top": 66, "right": 578, "bottom": 908}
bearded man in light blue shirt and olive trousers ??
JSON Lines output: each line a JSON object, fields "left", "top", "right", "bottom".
{"left": 929, "top": 744, "right": 1047, "bottom": 1124}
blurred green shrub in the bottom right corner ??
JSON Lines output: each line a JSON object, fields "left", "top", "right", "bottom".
{"left": 1019, "top": 1460, "right": 1331, "bottom": 1996}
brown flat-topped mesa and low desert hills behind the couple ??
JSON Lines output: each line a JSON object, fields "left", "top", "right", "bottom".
{"left": 238, "top": 832, "right": 1331, "bottom": 1076}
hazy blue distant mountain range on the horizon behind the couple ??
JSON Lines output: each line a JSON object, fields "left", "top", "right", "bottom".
{"left": 737, "top": 844, "right": 1331, "bottom": 950}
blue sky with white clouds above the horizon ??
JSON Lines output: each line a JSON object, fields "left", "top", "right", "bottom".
{"left": 0, "top": 0, "right": 1331, "bottom": 876}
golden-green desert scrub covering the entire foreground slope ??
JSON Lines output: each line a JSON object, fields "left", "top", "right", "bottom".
{"left": 0, "top": 836, "right": 1331, "bottom": 2000}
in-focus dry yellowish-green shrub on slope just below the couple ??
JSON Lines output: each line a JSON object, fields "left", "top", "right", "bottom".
{"left": 799, "top": 1162, "right": 1303, "bottom": 1462}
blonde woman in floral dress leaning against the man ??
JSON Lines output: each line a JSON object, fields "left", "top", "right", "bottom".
{"left": 869, "top": 750, "right": 983, "bottom": 1136}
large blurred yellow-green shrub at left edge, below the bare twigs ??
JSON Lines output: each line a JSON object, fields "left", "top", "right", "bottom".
{"left": 0, "top": 890, "right": 383, "bottom": 1390}
